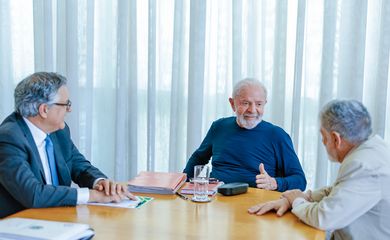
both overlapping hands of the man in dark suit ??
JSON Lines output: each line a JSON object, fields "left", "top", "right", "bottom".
{"left": 89, "top": 179, "right": 136, "bottom": 203}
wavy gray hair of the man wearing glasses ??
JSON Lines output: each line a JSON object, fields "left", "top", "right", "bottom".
{"left": 14, "top": 72, "right": 66, "bottom": 117}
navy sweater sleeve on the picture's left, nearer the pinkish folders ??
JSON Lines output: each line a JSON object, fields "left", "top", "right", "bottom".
{"left": 183, "top": 122, "right": 215, "bottom": 178}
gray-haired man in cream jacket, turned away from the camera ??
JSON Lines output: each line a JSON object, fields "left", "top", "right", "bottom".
{"left": 248, "top": 100, "right": 390, "bottom": 239}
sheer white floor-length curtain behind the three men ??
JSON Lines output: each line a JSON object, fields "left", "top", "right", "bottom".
{"left": 0, "top": 0, "right": 390, "bottom": 188}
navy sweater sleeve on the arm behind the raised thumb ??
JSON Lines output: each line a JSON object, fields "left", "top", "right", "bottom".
{"left": 275, "top": 131, "right": 306, "bottom": 192}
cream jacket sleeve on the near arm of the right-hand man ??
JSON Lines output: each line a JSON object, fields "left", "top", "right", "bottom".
{"left": 292, "top": 159, "right": 381, "bottom": 230}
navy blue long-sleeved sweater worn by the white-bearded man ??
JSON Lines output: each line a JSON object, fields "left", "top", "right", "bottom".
{"left": 184, "top": 117, "right": 306, "bottom": 192}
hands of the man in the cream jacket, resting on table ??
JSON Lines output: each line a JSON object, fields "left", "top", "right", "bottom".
{"left": 248, "top": 189, "right": 312, "bottom": 217}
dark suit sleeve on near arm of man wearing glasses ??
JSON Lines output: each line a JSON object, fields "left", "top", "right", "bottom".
{"left": 0, "top": 134, "right": 77, "bottom": 208}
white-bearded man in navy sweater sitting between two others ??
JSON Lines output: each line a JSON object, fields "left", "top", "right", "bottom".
{"left": 184, "top": 79, "right": 306, "bottom": 192}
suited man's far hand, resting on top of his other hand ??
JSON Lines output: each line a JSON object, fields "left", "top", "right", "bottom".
{"left": 94, "top": 179, "right": 136, "bottom": 200}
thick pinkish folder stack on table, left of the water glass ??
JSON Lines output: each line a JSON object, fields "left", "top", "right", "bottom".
{"left": 128, "top": 172, "right": 187, "bottom": 194}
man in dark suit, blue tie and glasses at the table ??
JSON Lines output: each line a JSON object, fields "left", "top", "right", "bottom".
{"left": 0, "top": 72, "right": 134, "bottom": 217}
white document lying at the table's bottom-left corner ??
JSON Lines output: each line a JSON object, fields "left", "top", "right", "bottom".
{"left": 0, "top": 218, "right": 95, "bottom": 240}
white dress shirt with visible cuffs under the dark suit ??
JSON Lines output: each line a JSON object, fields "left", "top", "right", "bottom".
{"left": 23, "top": 118, "right": 89, "bottom": 204}
